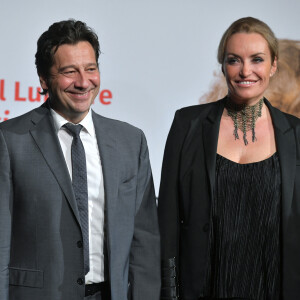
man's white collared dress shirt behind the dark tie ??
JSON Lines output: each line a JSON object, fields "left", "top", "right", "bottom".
{"left": 51, "top": 109, "right": 105, "bottom": 284}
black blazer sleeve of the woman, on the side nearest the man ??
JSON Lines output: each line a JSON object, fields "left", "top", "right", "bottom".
{"left": 158, "top": 110, "right": 187, "bottom": 300}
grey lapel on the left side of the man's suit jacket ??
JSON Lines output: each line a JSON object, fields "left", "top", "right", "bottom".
{"left": 30, "top": 105, "right": 80, "bottom": 224}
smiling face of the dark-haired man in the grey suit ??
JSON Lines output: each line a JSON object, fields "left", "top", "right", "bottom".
{"left": 40, "top": 41, "right": 100, "bottom": 123}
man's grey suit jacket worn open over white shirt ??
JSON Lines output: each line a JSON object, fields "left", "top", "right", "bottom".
{"left": 0, "top": 104, "right": 160, "bottom": 300}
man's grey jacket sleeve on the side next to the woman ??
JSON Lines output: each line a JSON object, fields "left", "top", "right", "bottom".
{"left": 128, "top": 133, "right": 161, "bottom": 300}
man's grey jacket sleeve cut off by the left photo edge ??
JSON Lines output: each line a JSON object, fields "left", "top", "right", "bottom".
{"left": 0, "top": 129, "right": 12, "bottom": 300}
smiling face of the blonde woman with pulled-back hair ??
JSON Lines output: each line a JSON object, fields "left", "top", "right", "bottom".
{"left": 222, "top": 33, "right": 277, "bottom": 105}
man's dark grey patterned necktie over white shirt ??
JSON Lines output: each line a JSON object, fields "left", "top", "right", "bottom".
{"left": 64, "top": 123, "right": 90, "bottom": 275}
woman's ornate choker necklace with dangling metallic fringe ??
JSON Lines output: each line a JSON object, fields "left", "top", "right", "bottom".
{"left": 225, "top": 98, "right": 264, "bottom": 146}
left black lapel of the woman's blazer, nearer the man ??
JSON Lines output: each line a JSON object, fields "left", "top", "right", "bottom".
{"left": 203, "top": 98, "right": 225, "bottom": 200}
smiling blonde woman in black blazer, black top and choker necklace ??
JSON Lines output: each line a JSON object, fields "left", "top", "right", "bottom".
{"left": 158, "top": 17, "right": 300, "bottom": 300}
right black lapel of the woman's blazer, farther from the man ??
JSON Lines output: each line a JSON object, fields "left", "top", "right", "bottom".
{"left": 265, "top": 101, "right": 296, "bottom": 233}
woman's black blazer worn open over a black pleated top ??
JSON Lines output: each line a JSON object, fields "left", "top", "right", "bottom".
{"left": 158, "top": 99, "right": 300, "bottom": 300}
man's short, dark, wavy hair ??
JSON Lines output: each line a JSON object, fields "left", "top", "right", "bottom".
{"left": 35, "top": 19, "right": 100, "bottom": 95}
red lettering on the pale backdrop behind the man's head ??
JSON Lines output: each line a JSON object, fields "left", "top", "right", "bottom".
{"left": 0, "top": 79, "right": 113, "bottom": 122}
